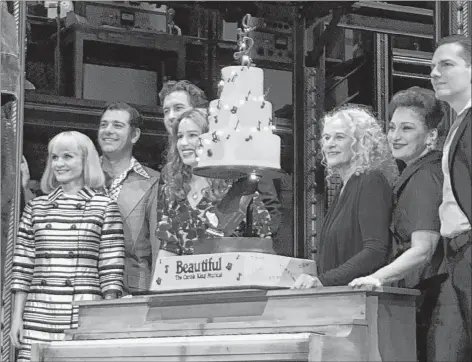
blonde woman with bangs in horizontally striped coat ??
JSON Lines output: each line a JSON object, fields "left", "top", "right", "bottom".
{"left": 11, "top": 131, "right": 124, "bottom": 362}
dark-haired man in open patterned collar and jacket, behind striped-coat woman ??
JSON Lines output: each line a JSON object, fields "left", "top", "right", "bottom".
{"left": 98, "top": 102, "right": 160, "bottom": 294}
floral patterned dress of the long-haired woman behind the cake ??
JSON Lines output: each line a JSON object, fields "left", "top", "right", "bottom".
{"left": 156, "top": 185, "right": 272, "bottom": 255}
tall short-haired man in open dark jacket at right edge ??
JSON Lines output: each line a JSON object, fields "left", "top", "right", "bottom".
{"left": 428, "top": 35, "right": 472, "bottom": 361}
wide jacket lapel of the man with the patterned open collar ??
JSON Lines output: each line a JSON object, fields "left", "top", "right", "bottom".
{"left": 118, "top": 172, "right": 151, "bottom": 220}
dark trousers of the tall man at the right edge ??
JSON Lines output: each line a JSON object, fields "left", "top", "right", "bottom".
{"left": 427, "top": 232, "right": 472, "bottom": 362}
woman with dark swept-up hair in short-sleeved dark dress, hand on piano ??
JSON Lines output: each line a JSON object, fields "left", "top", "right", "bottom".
{"left": 349, "top": 87, "right": 444, "bottom": 360}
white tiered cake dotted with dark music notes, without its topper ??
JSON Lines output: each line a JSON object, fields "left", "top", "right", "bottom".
{"left": 198, "top": 65, "right": 280, "bottom": 169}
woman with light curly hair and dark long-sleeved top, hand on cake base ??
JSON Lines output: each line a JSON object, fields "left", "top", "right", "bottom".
{"left": 292, "top": 105, "right": 398, "bottom": 289}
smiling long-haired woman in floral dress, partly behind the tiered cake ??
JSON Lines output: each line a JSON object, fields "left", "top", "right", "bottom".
{"left": 156, "top": 109, "right": 280, "bottom": 257}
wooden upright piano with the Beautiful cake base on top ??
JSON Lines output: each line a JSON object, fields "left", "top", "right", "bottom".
{"left": 32, "top": 287, "right": 419, "bottom": 362}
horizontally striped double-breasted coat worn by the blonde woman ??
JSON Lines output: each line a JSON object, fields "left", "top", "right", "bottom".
{"left": 12, "top": 187, "right": 124, "bottom": 361}
